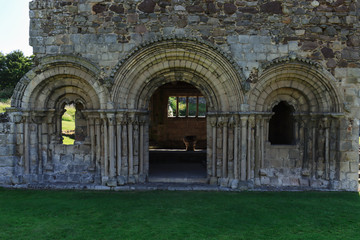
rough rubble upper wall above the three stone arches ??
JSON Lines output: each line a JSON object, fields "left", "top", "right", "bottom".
{"left": 30, "top": 0, "right": 360, "bottom": 75}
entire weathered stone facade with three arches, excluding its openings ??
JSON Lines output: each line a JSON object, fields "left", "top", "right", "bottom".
{"left": 0, "top": 0, "right": 360, "bottom": 191}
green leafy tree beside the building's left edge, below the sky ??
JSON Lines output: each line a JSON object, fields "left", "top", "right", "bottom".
{"left": 0, "top": 50, "right": 33, "bottom": 98}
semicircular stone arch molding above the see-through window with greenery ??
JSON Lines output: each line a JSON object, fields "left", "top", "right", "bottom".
{"left": 11, "top": 55, "right": 109, "bottom": 110}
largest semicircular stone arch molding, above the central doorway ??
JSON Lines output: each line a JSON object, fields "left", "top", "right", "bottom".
{"left": 111, "top": 38, "right": 245, "bottom": 111}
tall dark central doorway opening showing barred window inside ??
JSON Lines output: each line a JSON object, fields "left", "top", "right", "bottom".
{"left": 149, "top": 81, "right": 207, "bottom": 182}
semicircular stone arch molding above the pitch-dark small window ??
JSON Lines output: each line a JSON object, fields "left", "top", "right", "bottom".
{"left": 248, "top": 57, "right": 344, "bottom": 113}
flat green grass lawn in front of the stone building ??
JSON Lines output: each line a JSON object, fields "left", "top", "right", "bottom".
{"left": 0, "top": 189, "right": 360, "bottom": 240}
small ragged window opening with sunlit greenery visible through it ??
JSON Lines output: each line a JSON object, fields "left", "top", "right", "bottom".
{"left": 61, "top": 102, "right": 87, "bottom": 145}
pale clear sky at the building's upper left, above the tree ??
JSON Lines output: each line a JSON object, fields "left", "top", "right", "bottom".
{"left": 0, "top": 0, "right": 32, "bottom": 56}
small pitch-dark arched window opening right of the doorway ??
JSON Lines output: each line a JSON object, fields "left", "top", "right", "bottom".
{"left": 269, "top": 101, "right": 295, "bottom": 145}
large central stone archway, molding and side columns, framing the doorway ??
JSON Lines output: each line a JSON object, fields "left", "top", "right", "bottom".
{"left": 110, "top": 39, "right": 244, "bottom": 183}
